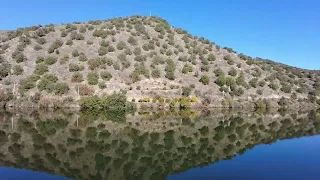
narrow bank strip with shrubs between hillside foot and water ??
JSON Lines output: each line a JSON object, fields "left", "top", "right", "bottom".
{"left": 0, "top": 94, "right": 319, "bottom": 111}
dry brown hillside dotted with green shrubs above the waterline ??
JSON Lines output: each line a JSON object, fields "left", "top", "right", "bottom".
{"left": 0, "top": 16, "right": 320, "bottom": 106}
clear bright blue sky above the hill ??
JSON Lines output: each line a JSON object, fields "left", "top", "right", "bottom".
{"left": 0, "top": 0, "right": 320, "bottom": 69}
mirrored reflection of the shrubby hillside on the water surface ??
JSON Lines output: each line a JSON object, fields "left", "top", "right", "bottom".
{"left": 0, "top": 111, "right": 320, "bottom": 179}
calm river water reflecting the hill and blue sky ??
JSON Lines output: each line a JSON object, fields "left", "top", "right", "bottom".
{"left": 0, "top": 111, "right": 320, "bottom": 180}
